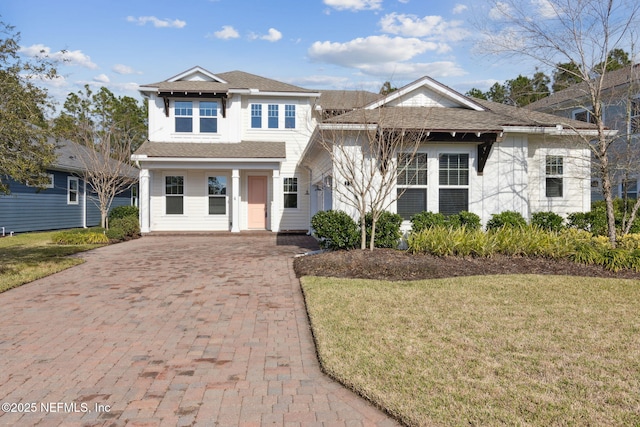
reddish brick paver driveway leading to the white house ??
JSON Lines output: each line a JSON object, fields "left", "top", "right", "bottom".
{"left": 0, "top": 234, "right": 395, "bottom": 426}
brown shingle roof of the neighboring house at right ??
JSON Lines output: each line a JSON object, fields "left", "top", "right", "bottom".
{"left": 525, "top": 64, "right": 640, "bottom": 111}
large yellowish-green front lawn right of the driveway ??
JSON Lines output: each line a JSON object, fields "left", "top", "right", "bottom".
{"left": 301, "top": 275, "right": 640, "bottom": 426}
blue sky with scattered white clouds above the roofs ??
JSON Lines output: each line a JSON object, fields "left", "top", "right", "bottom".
{"left": 0, "top": 0, "right": 535, "bottom": 108}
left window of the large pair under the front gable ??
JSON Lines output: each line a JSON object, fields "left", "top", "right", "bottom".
{"left": 397, "top": 153, "right": 427, "bottom": 220}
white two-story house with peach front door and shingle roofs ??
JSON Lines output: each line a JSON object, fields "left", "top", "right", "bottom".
{"left": 132, "top": 67, "right": 595, "bottom": 236}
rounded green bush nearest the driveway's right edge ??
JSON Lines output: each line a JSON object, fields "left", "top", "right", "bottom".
{"left": 311, "top": 210, "right": 360, "bottom": 249}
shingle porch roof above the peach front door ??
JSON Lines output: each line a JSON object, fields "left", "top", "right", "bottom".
{"left": 134, "top": 141, "right": 286, "bottom": 159}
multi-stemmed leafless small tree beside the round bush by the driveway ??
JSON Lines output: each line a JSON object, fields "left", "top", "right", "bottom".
{"left": 319, "top": 107, "right": 427, "bottom": 250}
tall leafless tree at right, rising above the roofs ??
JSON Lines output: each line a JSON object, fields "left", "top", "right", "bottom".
{"left": 478, "top": 0, "right": 640, "bottom": 245}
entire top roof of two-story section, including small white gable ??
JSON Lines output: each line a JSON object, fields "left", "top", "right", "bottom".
{"left": 139, "top": 67, "right": 316, "bottom": 95}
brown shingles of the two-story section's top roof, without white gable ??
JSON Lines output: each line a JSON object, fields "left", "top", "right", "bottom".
{"left": 143, "top": 71, "right": 314, "bottom": 93}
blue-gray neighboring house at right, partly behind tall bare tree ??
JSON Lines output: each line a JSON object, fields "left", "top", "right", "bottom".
{"left": 526, "top": 65, "right": 640, "bottom": 201}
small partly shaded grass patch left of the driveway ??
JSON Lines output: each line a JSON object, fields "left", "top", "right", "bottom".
{"left": 0, "top": 232, "right": 104, "bottom": 292}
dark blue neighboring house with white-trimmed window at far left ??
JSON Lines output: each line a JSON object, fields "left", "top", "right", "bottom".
{"left": 0, "top": 139, "right": 138, "bottom": 235}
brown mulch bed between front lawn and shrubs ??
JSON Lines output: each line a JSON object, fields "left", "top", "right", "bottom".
{"left": 293, "top": 249, "right": 640, "bottom": 280}
